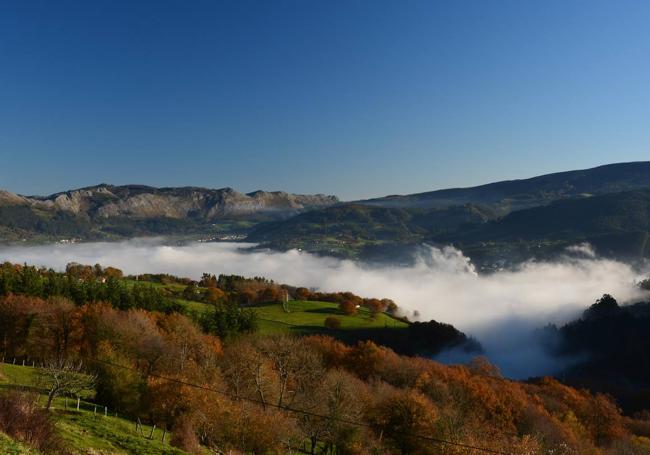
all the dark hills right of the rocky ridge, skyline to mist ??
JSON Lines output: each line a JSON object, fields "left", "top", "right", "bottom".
{"left": 249, "top": 162, "right": 650, "bottom": 268}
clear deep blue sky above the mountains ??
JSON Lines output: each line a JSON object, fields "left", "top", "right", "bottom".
{"left": 0, "top": 0, "right": 650, "bottom": 199}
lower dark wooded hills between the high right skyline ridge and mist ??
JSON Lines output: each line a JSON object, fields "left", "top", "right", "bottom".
{"left": 249, "top": 190, "right": 650, "bottom": 267}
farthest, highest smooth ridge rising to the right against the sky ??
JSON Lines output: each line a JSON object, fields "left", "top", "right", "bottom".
{"left": 358, "top": 161, "right": 650, "bottom": 211}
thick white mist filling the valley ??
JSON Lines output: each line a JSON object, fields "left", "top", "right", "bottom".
{"left": 0, "top": 239, "right": 644, "bottom": 377}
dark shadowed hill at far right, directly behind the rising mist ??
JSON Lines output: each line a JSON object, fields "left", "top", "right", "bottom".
{"left": 429, "top": 190, "right": 650, "bottom": 264}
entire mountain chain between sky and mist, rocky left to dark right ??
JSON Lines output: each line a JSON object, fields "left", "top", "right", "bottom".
{"left": 0, "top": 162, "right": 650, "bottom": 268}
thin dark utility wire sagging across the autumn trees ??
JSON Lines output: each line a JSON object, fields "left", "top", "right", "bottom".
{"left": 88, "top": 357, "right": 511, "bottom": 455}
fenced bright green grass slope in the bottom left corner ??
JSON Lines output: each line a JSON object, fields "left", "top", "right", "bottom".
{"left": 0, "top": 364, "right": 185, "bottom": 455}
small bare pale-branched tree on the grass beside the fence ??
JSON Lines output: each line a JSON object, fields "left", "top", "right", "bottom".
{"left": 39, "top": 357, "right": 97, "bottom": 409}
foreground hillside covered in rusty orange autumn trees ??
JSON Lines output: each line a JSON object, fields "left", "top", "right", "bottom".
{"left": 0, "top": 265, "right": 650, "bottom": 454}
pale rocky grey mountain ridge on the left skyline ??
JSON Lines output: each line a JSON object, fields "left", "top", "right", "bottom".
{"left": 0, "top": 184, "right": 338, "bottom": 241}
